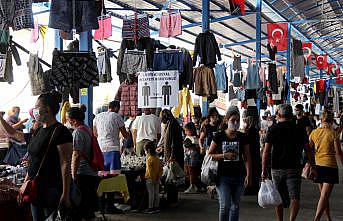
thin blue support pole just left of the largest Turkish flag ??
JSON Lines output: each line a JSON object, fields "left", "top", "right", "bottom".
{"left": 256, "top": 0, "right": 262, "bottom": 115}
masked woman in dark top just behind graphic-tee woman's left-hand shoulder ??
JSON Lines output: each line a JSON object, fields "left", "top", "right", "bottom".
{"left": 199, "top": 107, "right": 221, "bottom": 155}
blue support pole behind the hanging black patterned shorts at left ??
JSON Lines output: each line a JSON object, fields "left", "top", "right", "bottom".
{"left": 80, "top": 32, "right": 93, "bottom": 127}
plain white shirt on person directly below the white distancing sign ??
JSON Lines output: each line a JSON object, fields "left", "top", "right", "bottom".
{"left": 132, "top": 114, "right": 161, "bottom": 143}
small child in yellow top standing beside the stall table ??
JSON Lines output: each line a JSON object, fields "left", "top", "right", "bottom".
{"left": 144, "top": 141, "right": 163, "bottom": 214}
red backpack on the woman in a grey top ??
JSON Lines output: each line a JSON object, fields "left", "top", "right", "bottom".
{"left": 80, "top": 127, "right": 105, "bottom": 171}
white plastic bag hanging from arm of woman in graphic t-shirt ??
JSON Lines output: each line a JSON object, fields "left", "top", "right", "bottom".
{"left": 201, "top": 154, "right": 218, "bottom": 185}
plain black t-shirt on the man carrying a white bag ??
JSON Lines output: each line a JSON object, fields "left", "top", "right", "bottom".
{"left": 266, "top": 121, "right": 308, "bottom": 169}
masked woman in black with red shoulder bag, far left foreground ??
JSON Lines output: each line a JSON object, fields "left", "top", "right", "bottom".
{"left": 25, "top": 92, "right": 73, "bottom": 221}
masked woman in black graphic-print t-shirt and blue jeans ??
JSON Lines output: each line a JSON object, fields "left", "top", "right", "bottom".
{"left": 209, "top": 106, "right": 251, "bottom": 221}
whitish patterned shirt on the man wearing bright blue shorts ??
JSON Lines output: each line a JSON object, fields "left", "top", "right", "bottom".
{"left": 94, "top": 112, "right": 125, "bottom": 152}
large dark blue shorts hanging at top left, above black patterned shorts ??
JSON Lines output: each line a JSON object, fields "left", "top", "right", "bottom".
{"left": 49, "top": 0, "right": 99, "bottom": 33}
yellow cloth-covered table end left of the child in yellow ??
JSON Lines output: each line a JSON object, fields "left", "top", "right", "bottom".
{"left": 97, "top": 174, "right": 130, "bottom": 203}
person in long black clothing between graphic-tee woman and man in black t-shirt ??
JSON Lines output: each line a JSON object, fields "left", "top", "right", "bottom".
{"left": 243, "top": 116, "right": 262, "bottom": 195}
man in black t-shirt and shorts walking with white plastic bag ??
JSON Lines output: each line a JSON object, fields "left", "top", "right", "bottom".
{"left": 262, "top": 104, "right": 314, "bottom": 220}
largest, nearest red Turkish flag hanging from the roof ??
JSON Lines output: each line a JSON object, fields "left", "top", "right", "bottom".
{"left": 267, "top": 23, "right": 288, "bottom": 51}
